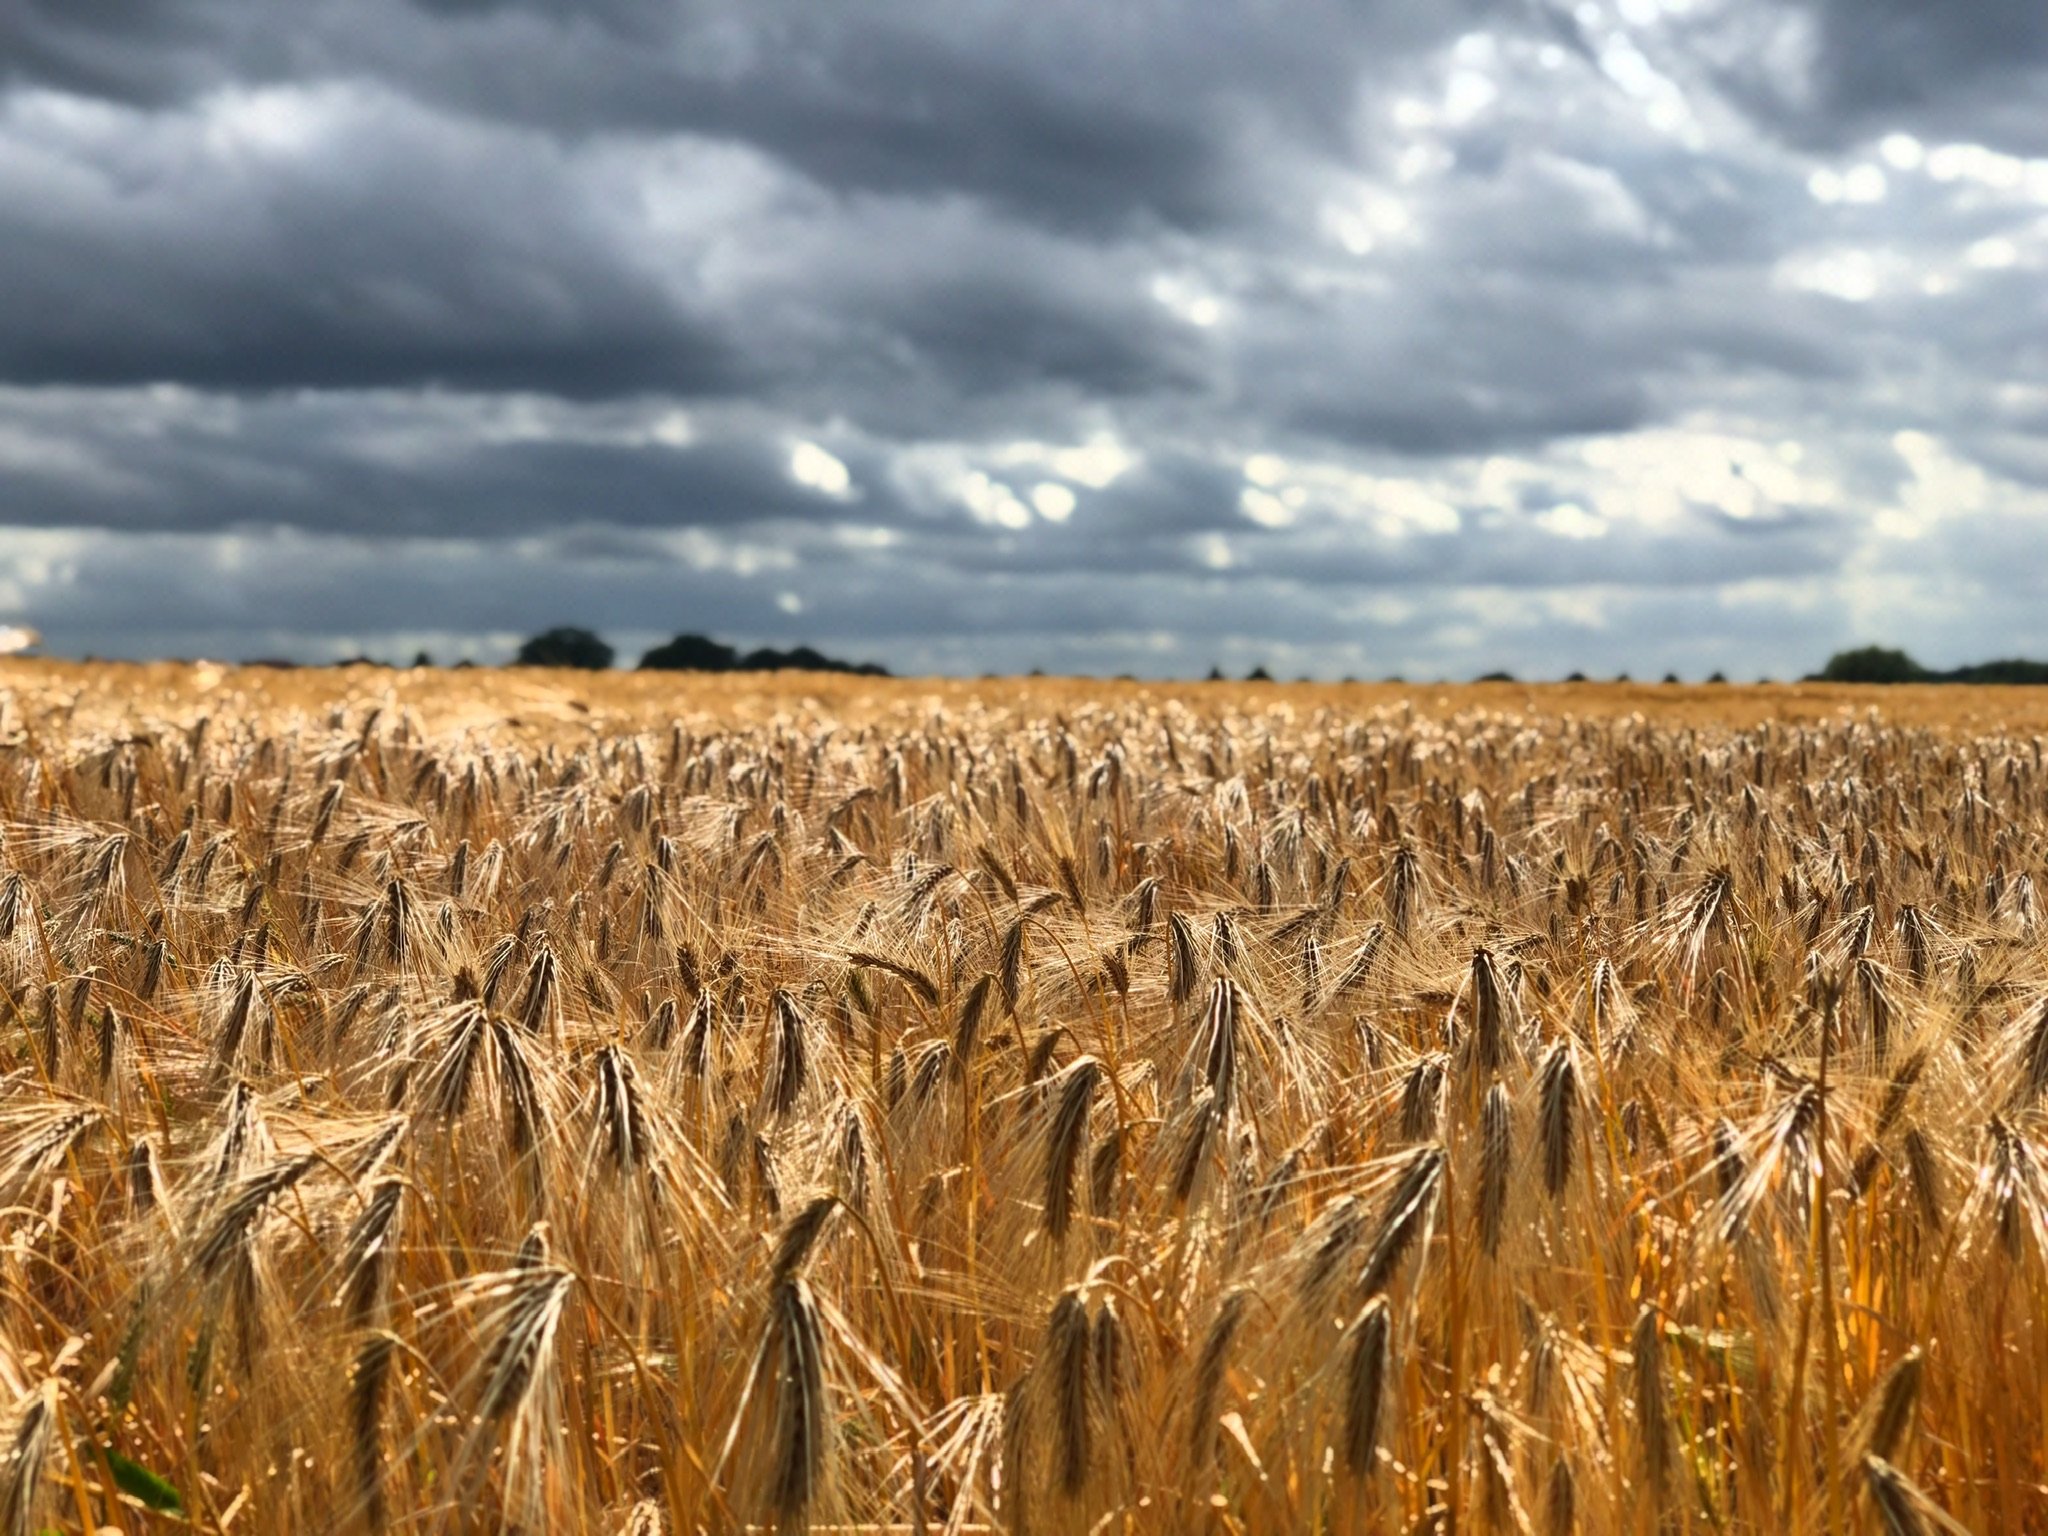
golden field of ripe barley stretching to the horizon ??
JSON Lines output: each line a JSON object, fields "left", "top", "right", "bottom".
{"left": 0, "top": 662, "right": 2048, "bottom": 1536}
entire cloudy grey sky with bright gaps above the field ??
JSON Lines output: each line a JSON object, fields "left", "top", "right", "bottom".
{"left": 0, "top": 0, "right": 2048, "bottom": 678}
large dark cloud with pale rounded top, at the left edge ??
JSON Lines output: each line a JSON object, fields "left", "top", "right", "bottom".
{"left": 0, "top": 88, "right": 745, "bottom": 395}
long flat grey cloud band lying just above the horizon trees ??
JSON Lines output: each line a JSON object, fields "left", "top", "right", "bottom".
{"left": 8, "top": 493, "right": 2042, "bottom": 678}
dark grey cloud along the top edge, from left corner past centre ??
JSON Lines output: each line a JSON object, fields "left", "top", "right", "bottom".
{"left": 0, "top": 0, "right": 1493, "bottom": 227}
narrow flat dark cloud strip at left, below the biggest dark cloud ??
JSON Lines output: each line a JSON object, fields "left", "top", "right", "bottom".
{"left": 0, "top": 391, "right": 876, "bottom": 539}
